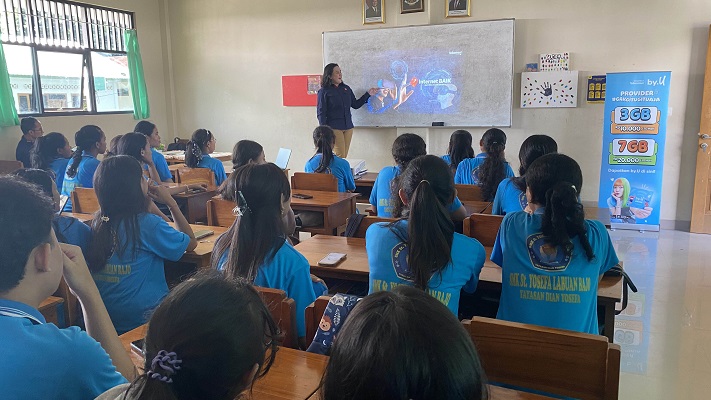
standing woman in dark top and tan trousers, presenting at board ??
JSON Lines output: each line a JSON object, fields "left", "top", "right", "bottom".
{"left": 316, "top": 63, "right": 378, "bottom": 158}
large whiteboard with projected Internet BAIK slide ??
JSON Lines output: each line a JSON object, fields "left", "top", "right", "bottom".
{"left": 322, "top": 19, "right": 515, "bottom": 127}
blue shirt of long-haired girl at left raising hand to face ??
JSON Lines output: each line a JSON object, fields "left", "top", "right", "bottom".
{"left": 94, "top": 213, "right": 190, "bottom": 335}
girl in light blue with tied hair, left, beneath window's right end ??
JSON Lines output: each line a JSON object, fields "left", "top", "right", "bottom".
{"left": 62, "top": 125, "right": 106, "bottom": 212}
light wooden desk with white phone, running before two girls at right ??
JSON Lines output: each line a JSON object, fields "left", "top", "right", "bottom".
{"left": 295, "top": 235, "right": 622, "bottom": 343}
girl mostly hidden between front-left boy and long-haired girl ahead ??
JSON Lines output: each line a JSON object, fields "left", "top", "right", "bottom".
{"left": 13, "top": 168, "right": 91, "bottom": 254}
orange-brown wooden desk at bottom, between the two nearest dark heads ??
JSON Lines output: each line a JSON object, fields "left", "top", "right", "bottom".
{"left": 120, "top": 325, "right": 328, "bottom": 400}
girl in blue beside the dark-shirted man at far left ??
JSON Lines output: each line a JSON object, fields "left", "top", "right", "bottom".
{"left": 25, "top": 132, "right": 72, "bottom": 188}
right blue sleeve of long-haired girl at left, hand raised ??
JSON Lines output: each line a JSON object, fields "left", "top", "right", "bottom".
{"left": 140, "top": 214, "right": 190, "bottom": 261}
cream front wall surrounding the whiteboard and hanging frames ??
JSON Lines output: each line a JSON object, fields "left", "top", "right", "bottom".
{"left": 168, "top": 0, "right": 711, "bottom": 226}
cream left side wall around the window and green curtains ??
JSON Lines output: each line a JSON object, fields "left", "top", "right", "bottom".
{"left": 0, "top": 0, "right": 173, "bottom": 160}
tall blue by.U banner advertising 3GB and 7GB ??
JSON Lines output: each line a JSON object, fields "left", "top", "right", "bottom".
{"left": 598, "top": 72, "right": 671, "bottom": 230}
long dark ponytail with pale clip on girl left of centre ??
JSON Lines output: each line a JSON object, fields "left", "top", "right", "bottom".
{"left": 211, "top": 163, "right": 291, "bottom": 282}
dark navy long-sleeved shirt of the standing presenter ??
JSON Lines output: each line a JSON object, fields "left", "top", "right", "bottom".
{"left": 316, "top": 82, "right": 370, "bottom": 131}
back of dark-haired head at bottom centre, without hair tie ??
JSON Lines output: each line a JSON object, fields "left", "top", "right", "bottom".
{"left": 321, "top": 286, "right": 489, "bottom": 400}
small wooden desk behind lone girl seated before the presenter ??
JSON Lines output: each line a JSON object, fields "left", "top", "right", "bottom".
{"left": 291, "top": 189, "right": 358, "bottom": 235}
